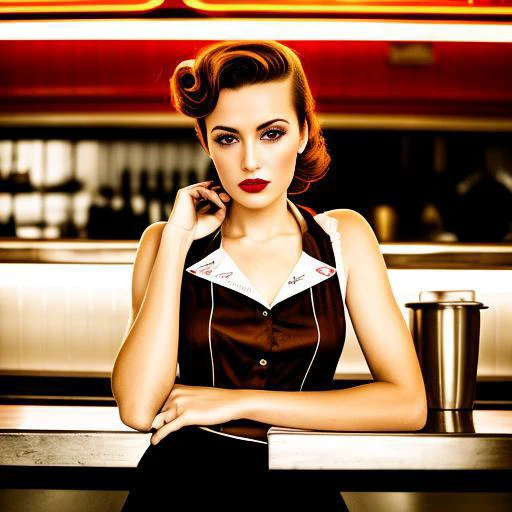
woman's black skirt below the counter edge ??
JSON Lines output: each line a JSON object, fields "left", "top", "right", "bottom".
{"left": 122, "top": 425, "right": 348, "bottom": 512}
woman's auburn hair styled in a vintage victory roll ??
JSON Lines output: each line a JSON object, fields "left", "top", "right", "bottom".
{"left": 170, "top": 41, "right": 331, "bottom": 195}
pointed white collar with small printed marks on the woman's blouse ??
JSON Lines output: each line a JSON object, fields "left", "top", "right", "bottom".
{"left": 185, "top": 205, "right": 336, "bottom": 309}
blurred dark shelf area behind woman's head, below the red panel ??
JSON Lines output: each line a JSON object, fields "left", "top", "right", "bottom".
{"left": 0, "top": 127, "right": 512, "bottom": 242}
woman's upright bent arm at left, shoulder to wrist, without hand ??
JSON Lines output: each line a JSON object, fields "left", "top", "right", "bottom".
{"left": 111, "top": 222, "right": 192, "bottom": 431}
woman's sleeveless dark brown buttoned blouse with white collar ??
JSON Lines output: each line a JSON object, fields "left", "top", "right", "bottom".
{"left": 178, "top": 199, "right": 346, "bottom": 443}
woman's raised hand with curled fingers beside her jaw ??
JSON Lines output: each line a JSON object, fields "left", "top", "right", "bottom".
{"left": 167, "top": 180, "right": 231, "bottom": 240}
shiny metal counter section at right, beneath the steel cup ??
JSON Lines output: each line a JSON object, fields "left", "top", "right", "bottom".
{"left": 268, "top": 410, "right": 512, "bottom": 470}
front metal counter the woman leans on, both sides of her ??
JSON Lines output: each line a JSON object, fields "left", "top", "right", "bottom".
{"left": 0, "top": 404, "right": 512, "bottom": 484}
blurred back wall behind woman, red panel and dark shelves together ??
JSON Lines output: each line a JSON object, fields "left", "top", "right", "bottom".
{"left": 0, "top": 36, "right": 512, "bottom": 243}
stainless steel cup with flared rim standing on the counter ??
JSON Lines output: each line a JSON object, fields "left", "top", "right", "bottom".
{"left": 405, "top": 290, "right": 488, "bottom": 409}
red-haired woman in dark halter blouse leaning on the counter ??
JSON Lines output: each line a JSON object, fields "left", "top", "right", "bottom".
{"left": 112, "top": 41, "right": 426, "bottom": 510}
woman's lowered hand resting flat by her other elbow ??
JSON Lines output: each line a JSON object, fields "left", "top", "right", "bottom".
{"left": 151, "top": 384, "right": 241, "bottom": 444}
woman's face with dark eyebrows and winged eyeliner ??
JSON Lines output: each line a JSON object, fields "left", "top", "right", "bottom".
{"left": 205, "top": 75, "right": 308, "bottom": 208}
